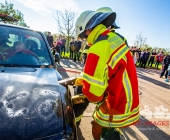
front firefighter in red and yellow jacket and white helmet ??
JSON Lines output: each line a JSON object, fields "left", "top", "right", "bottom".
{"left": 75, "top": 10, "right": 139, "bottom": 140}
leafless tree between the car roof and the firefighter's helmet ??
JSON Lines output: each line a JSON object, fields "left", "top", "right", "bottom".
{"left": 54, "top": 10, "right": 76, "bottom": 50}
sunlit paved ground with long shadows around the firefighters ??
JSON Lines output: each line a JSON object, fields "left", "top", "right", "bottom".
{"left": 59, "top": 59, "right": 170, "bottom": 140}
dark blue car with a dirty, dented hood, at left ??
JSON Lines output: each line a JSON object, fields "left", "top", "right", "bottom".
{"left": 0, "top": 23, "right": 77, "bottom": 140}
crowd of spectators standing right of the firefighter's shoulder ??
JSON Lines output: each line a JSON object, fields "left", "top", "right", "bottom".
{"left": 130, "top": 46, "right": 170, "bottom": 82}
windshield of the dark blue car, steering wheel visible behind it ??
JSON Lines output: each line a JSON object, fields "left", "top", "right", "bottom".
{"left": 0, "top": 26, "right": 52, "bottom": 67}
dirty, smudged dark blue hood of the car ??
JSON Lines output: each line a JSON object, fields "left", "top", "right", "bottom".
{"left": 0, "top": 68, "right": 66, "bottom": 139}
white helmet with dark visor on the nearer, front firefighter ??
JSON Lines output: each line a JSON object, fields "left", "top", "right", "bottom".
{"left": 75, "top": 10, "right": 116, "bottom": 38}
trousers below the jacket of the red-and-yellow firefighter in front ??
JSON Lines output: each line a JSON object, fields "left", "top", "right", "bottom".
{"left": 92, "top": 120, "right": 120, "bottom": 140}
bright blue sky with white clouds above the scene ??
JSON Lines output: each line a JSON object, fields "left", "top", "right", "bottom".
{"left": 0, "top": 0, "right": 170, "bottom": 48}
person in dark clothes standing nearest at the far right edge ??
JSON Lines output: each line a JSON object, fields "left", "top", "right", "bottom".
{"left": 160, "top": 54, "right": 170, "bottom": 78}
